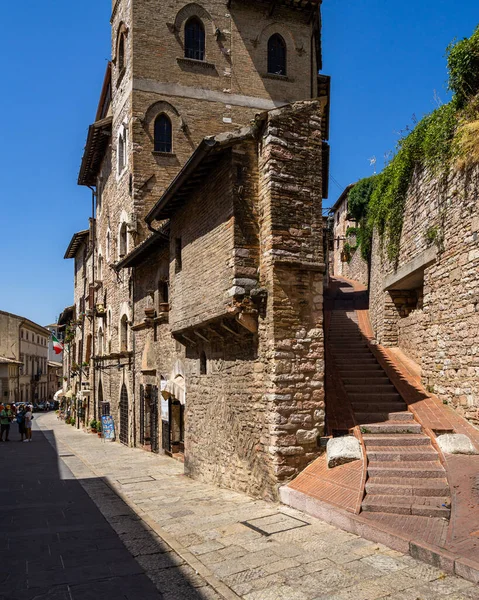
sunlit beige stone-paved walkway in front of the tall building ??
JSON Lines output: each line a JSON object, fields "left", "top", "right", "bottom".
{"left": 31, "top": 414, "right": 479, "bottom": 600}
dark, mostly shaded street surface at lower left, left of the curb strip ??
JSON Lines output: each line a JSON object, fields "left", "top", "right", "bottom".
{"left": 0, "top": 415, "right": 162, "bottom": 600}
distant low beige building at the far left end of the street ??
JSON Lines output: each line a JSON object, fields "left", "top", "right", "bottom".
{"left": 0, "top": 311, "right": 50, "bottom": 403}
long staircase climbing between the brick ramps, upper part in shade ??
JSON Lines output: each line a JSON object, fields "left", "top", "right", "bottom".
{"left": 328, "top": 310, "right": 450, "bottom": 519}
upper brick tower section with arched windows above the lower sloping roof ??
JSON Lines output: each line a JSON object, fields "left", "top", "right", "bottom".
{"left": 111, "top": 0, "right": 321, "bottom": 236}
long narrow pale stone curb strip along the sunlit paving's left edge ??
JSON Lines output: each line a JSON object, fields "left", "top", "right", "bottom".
{"left": 38, "top": 423, "right": 242, "bottom": 600}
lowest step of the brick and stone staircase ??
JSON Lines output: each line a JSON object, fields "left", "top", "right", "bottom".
{"left": 361, "top": 495, "right": 451, "bottom": 519}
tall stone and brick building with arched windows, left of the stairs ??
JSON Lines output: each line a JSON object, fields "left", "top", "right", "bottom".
{"left": 64, "top": 0, "right": 329, "bottom": 495}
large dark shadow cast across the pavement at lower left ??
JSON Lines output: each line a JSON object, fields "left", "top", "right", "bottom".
{"left": 0, "top": 425, "right": 217, "bottom": 600}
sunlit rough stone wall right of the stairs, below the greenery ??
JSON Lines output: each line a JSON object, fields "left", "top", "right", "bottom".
{"left": 370, "top": 167, "right": 479, "bottom": 424}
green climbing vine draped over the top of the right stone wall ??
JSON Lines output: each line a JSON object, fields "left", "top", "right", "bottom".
{"left": 348, "top": 27, "right": 479, "bottom": 260}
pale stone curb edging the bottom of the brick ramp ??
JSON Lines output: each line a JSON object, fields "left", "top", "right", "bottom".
{"left": 279, "top": 486, "right": 479, "bottom": 583}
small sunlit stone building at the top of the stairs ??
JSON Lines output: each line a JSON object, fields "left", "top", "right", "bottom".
{"left": 331, "top": 183, "right": 368, "bottom": 286}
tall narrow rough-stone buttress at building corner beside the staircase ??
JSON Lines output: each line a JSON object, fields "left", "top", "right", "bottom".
{"left": 258, "top": 102, "right": 324, "bottom": 481}
